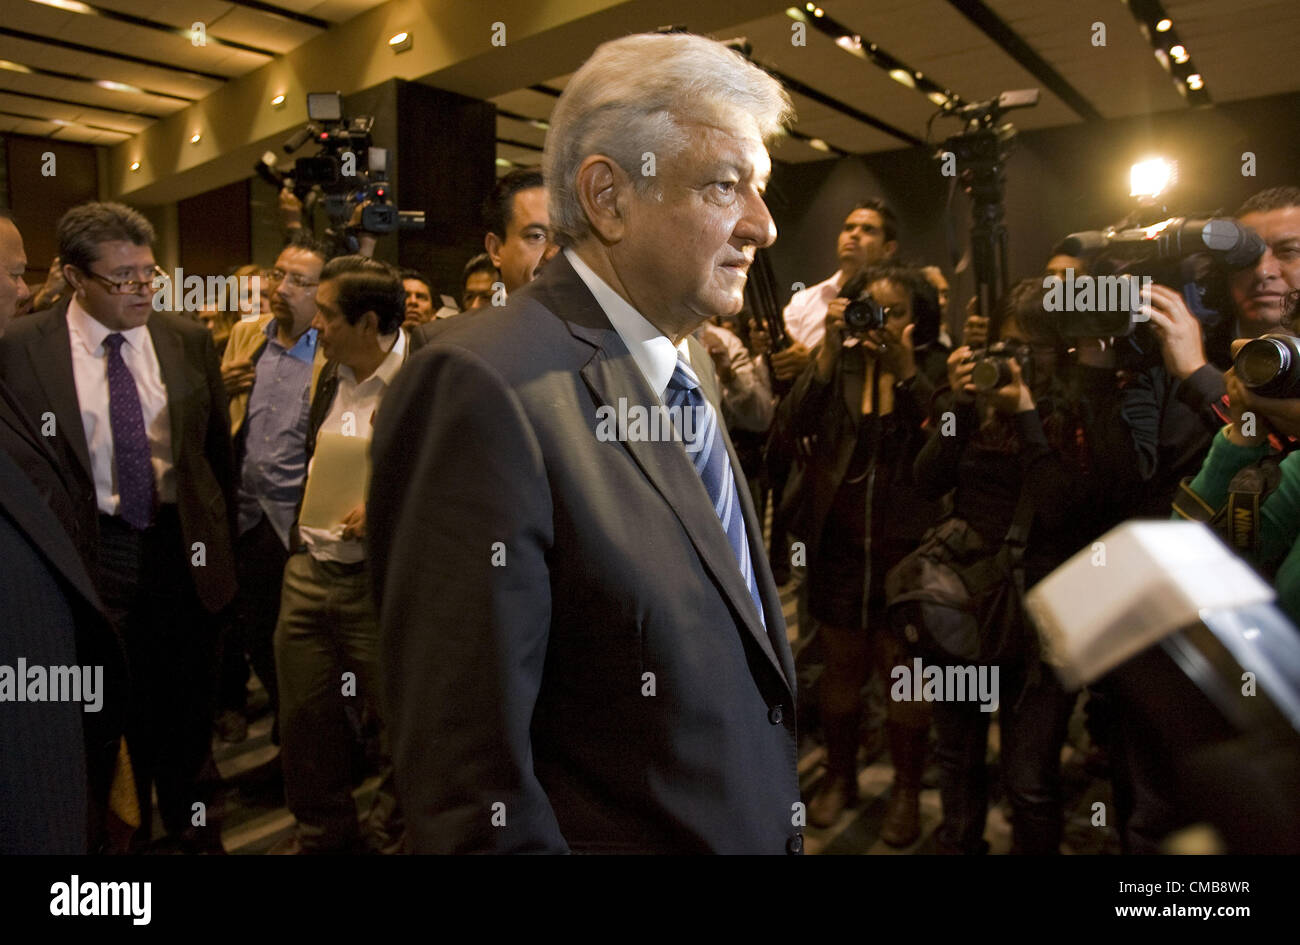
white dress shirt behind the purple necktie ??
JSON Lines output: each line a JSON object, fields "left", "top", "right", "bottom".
{"left": 66, "top": 296, "right": 176, "bottom": 515}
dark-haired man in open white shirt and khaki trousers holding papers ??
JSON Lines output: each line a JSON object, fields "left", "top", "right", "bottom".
{"left": 276, "top": 256, "right": 407, "bottom": 853}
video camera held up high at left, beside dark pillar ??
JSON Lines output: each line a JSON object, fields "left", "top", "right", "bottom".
{"left": 256, "top": 92, "right": 424, "bottom": 252}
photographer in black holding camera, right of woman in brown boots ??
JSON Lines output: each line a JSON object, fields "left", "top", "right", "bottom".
{"left": 914, "top": 279, "right": 1134, "bottom": 854}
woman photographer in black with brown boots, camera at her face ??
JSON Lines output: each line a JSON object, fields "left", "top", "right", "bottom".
{"left": 783, "top": 265, "right": 936, "bottom": 846}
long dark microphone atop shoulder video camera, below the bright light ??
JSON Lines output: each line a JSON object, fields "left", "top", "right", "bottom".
{"left": 1061, "top": 217, "right": 1265, "bottom": 269}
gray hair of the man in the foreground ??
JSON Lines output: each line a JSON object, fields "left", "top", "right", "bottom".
{"left": 542, "top": 32, "right": 794, "bottom": 246}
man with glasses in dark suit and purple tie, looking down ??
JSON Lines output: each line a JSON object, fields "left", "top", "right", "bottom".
{"left": 0, "top": 203, "right": 235, "bottom": 851}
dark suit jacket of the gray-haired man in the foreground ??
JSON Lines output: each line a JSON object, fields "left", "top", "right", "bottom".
{"left": 367, "top": 256, "right": 802, "bottom": 853}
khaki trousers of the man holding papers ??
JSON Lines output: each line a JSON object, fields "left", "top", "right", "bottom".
{"left": 276, "top": 552, "right": 402, "bottom": 853}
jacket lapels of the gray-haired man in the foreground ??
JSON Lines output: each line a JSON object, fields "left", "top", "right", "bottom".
{"left": 543, "top": 256, "right": 793, "bottom": 692}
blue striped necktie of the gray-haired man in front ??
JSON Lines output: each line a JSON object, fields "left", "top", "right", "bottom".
{"left": 663, "top": 354, "right": 767, "bottom": 628}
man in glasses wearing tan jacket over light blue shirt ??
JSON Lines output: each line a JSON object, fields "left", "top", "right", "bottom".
{"left": 217, "top": 233, "right": 328, "bottom": 742}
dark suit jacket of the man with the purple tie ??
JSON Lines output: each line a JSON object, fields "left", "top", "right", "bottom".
{"left": 0, "top": 300, "right": 237, "bottom": 612}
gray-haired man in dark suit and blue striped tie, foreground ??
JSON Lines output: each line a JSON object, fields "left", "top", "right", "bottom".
{"left": 368, "top": 35, "right": 802, "bottom": 853}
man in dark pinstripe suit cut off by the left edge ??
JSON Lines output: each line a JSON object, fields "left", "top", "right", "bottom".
{"left": 0, "top": 214, "right": 125, "bottom": 854}
